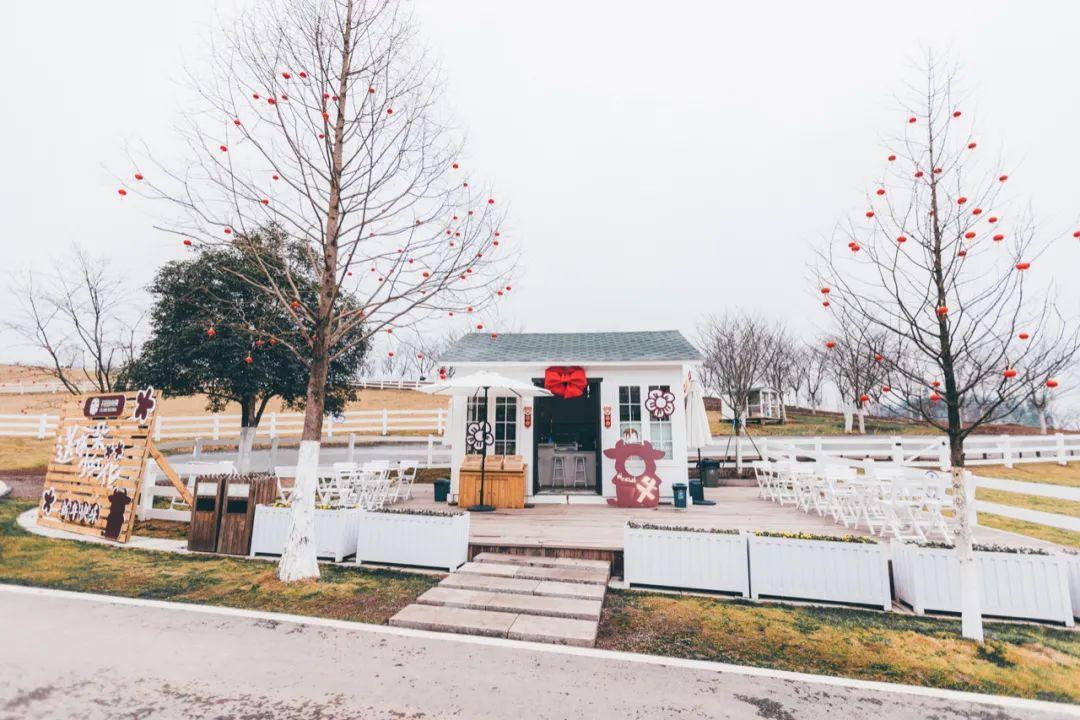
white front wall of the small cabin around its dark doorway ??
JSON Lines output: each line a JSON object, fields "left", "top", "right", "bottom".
{"left": 447, "top": 363, "right": 688, "bottom": 500}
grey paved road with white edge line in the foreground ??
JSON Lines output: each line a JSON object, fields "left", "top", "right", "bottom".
{"left": 0, "top": 586, "right": 1077, "bottom": 720}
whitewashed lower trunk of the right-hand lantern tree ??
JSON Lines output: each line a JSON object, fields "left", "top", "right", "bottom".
{"left": 949, "top": 435, "right": 983, "bottom": 642}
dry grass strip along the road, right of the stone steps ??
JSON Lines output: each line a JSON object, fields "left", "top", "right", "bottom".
{"left": 597, "top": 590, "right": 1080, "bottom": 703}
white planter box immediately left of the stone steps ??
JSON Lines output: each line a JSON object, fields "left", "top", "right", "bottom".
{"left": 355, "top": 513, "right": 469, "bottom": 572}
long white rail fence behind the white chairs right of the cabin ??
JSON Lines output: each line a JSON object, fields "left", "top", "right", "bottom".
{"left": 690, "top": 433, "right": 1080, "bottom": 470}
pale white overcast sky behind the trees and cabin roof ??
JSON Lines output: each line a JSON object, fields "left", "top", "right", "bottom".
{"left": 0, "top": 0, "right": 1080, "bottom": 362}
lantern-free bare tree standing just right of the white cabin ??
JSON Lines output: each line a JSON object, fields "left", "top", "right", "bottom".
{"left": 700, "top": 311, "right": 772, "bottom": 459}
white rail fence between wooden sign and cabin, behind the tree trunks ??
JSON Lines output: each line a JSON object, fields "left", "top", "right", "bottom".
{"left": 153, "top": 408, "right": 447, "bottom": 440}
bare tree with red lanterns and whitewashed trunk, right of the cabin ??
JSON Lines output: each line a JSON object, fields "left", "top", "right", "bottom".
{"left": 818, "top": 57, "right": 1078, "bottom": 639}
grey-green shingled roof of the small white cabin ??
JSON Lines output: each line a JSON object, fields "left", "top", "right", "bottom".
{"left": 440, "top": 330, "right": 702, "bottom": 363}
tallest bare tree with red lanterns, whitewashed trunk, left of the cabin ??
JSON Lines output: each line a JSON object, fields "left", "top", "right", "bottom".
{"left": 131, "top": 0, "right": 513, "bottom": 581}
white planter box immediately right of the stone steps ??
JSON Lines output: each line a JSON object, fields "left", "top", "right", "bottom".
{"left": 623, "top": 525, "right": 750, "bottom": 597}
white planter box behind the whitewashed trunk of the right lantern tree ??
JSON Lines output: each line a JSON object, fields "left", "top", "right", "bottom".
{"left": 892, "top": 543, "right": 1074, "bottom": 625}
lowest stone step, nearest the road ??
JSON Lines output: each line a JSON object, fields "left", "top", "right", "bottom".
{"left": 390, "top": 604, "right": 597, "bottom": 648}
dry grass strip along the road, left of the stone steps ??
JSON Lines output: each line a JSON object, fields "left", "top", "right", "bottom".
{"left": 0, "top": 500, "right": 440, "bottom": 624}
